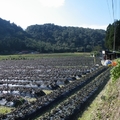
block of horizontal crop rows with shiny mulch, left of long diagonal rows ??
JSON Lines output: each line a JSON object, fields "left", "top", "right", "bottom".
{"left": 0, "top": 57, "right": 98, "bottom": 105}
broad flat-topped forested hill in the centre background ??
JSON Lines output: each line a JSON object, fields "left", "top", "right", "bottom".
{"left": 26, "top": 24, "right": 105, "bottom": 52}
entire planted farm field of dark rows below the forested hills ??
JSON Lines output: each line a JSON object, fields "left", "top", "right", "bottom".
{"left": 0, "top": 54, "right": 109, "bottom": 120}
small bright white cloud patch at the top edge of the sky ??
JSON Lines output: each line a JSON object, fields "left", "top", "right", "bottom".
{"left": 39, "top": 0, "right": 65, "bottom": 7}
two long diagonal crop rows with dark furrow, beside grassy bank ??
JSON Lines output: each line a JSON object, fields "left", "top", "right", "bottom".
{"left": 3, "top": 67, "right": 109, "bottom": 120}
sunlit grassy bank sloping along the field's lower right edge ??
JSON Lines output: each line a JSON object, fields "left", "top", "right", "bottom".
{"left": 78, "top": 79, "right": 120, "bottom": 120}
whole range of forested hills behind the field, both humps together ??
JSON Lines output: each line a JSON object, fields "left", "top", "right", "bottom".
{"left": 0, "top": 18, "right": 105, "bottom": 54}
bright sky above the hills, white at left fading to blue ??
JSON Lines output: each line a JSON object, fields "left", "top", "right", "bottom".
{"left": 0, "top": 0, "right": 120, "bottom": 30}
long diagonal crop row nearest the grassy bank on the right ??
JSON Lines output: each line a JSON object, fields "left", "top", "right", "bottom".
{"left": 39, "top": 70, "right": 109, "bottom": 120}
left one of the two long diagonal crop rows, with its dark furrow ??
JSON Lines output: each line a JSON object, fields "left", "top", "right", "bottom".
{"left": 2, "top": 67, "right": 109, "bottom": 120}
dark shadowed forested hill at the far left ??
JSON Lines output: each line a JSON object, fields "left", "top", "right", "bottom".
{"left": 0, "top": 18, "right": 30, "bottom": 54}
